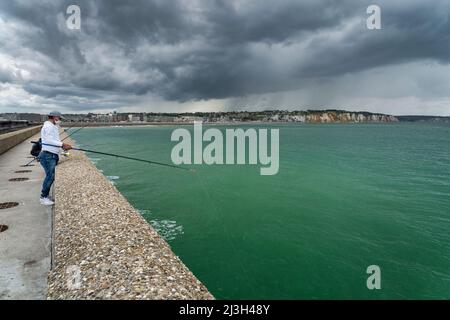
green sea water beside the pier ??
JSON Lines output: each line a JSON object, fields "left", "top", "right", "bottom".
{"left": 74, "top": 123, "right": 450, "bottom": 299}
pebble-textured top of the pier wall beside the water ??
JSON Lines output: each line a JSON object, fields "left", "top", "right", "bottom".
{"left": 48, "top": 141, "right": 214, "bottom": 300}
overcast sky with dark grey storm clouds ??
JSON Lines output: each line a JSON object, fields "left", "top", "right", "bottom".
{"left": 0, "top": 0, "right": 450, "bottom": 116}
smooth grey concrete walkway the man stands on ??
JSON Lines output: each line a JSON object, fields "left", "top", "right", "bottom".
{"left": 0, "top": 129, "right": 52, "bottom": 299}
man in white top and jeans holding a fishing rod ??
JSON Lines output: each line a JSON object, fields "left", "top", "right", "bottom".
{"left": 39, "top": 111, "right": 72, "bottom": 206}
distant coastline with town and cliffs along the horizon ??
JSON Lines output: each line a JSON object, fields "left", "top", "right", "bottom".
{"left": 0, "top": 109, "right": 450, "bottom": 129}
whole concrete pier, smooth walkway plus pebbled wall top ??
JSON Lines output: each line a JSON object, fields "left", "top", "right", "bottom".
{"left": 0, "top": 131, "right": 214, "bottom": 300}
